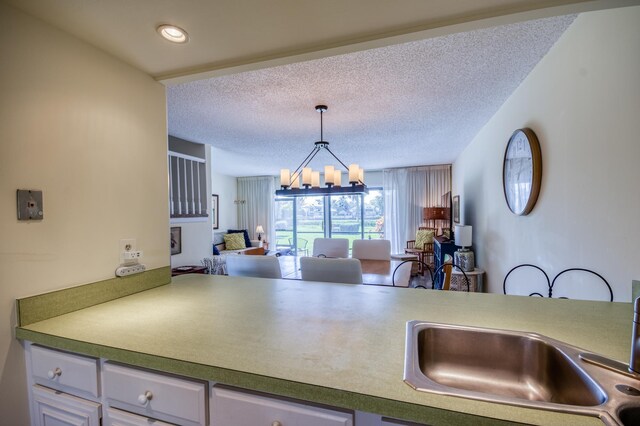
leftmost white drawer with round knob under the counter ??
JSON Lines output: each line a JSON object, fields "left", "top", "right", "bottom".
{"left": 31, "top": 345, "right": 99, "bottom": 398}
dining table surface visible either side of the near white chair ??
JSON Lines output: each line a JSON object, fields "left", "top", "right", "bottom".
{"left": 278, "top": 256, "right": 408, "bottom": 287}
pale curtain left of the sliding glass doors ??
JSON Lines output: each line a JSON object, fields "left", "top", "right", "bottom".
{"left": 238, "top": 176, "right": 276, "bottom": 241}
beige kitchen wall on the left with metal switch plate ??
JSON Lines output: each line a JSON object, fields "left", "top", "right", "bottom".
{"left": 0, "top": 3, "right": 169, "bottom": 425}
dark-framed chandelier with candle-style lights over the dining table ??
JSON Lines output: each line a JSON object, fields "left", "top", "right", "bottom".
{"left": 276, "top": 105, "right": 369, "bottom": 197}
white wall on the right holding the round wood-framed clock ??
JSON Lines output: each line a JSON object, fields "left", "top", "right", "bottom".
{"left": 453, "top": 7, "right": 640, "bottom": 301}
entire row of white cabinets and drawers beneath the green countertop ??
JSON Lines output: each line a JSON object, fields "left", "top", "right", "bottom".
{"left": 25, "top": 342, "right": 400, "bottom": 426}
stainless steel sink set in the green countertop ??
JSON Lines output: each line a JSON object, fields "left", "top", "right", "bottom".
{"left": 404, "top": 321, "right": 640, "bottom": 425}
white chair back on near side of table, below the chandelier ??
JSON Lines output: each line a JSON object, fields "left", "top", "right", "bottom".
{"left": 300, "top": 257, "right": 362, "bottom": 284}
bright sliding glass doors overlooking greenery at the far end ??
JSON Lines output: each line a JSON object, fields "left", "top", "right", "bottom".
{"left": 275, "top": 188, "right": 384, "bottom": 254}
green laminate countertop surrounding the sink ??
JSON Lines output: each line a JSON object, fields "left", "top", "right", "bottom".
{"left": 17, "top": 274, "right": 633, "bottom": 425}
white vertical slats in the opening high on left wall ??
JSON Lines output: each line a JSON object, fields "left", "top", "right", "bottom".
{"left": 169, "top": 151, "right": 208, "bottom": 218}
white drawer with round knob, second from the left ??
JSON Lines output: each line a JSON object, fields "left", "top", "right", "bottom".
{"left": 103, "top": 362, "right": 207, "bottom": 426}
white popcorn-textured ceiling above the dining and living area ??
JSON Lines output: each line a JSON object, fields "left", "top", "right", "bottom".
{"left": 167, "top": 15, "right": 575, "bottom": 176}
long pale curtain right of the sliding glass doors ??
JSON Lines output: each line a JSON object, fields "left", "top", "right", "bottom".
{"left": 382, "top": 164, "right": 451, "bottom": 253}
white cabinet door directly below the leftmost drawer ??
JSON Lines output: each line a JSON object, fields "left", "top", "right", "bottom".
{"left": 31, "top": 385, "right": 101, "bottom": 426}
